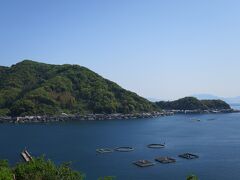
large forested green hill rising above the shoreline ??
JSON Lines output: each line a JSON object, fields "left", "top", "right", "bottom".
{"left": 0, "top": 60, "right": 157, "bottom": 116}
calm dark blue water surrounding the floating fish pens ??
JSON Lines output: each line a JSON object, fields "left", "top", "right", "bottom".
{"left": 0, "top": 113, "right": 240, "bottom": 180}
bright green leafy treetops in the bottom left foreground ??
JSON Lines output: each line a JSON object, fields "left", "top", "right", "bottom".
{"left": 0, "top": 157, "right": 85, "bottom": 180}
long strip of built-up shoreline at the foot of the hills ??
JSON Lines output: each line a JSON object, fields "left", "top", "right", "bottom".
{"left": 0, "top": 109, "right": 240, "bottom": 123}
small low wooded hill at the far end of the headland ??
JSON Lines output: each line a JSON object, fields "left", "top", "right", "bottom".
{"left": 156, "top": 97, "right": 231, "bottom": 110}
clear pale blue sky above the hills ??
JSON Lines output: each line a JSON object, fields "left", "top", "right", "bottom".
{"left": 0, "top": 0, "right": 240, "bottom": 99}
